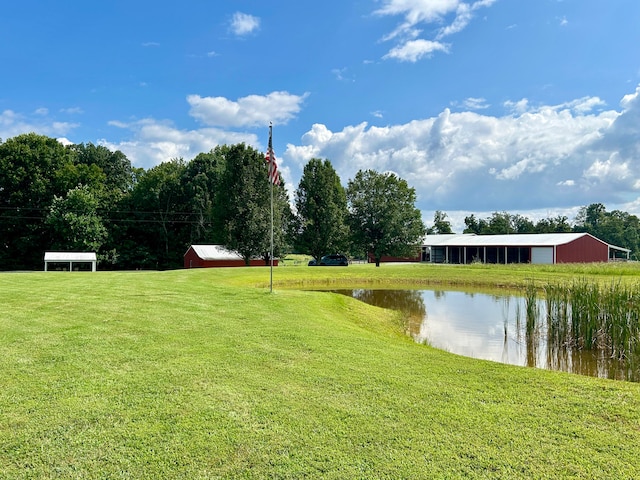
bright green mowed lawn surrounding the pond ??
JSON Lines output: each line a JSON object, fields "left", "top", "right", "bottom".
{"left": 0, "top": 265, "right": 640, "bottom": 479}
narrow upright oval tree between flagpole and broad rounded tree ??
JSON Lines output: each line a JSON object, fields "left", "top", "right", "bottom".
{"left": 295, "top": 158, "right": 349, "bottom": 262}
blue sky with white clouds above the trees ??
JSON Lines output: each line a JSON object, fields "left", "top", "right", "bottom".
{"left": 0, "top": 0, "right": 640, "bottom": 231}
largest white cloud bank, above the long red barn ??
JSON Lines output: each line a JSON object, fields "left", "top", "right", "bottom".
{"left": 285, "top": 87, "right": 640, "bottom": 211}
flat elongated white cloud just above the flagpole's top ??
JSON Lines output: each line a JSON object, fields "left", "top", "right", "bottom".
{"left": 187, "top": 92, "right": 307, "bottom": 127}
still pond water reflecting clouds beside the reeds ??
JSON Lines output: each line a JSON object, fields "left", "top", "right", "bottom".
{"left": 334, "top": 289, "right": 640, "bottom": 382}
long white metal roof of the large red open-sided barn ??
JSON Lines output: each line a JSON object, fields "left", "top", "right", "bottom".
{"left": 424, "top": 233, "right": 626, "bottom": 250}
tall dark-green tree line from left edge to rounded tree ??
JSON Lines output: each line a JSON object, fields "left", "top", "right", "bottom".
{"left": 0, "top": 133, "right": 426, "bottom": 270}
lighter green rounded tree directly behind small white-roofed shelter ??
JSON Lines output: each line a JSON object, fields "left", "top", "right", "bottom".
{"left": 45, "top": 186, "right": 107, "bottom": 252}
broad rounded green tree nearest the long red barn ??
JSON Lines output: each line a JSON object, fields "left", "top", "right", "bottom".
{"left": 347, "top": 170, "right": 426, "bottom": 266}
